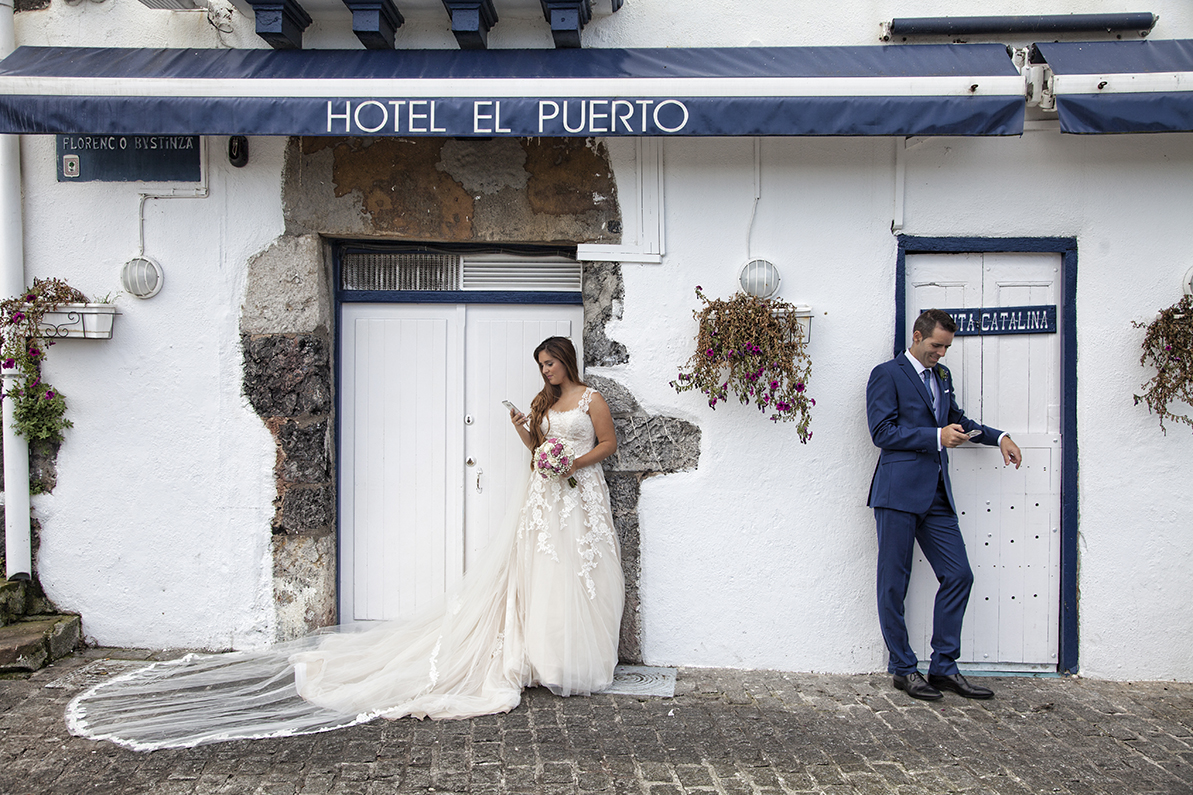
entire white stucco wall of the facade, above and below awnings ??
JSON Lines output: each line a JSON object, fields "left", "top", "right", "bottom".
{"left": 9, "top": 0, "right": 1193, "bottom": 679}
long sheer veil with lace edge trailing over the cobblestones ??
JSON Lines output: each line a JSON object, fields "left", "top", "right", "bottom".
{"left": 66, "top": 472, "right": 539, "bottom": 751}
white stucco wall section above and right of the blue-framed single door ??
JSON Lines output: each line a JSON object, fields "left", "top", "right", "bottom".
{"left": 907, "top": 133, "right": 1193, "bottom": 679}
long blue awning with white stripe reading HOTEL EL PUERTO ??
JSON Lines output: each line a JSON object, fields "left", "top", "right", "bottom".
{"left": 0, "top": 44, "right": 1025, "bottom": 137}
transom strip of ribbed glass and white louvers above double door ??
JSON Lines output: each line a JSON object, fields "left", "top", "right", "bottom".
{"left": 340, "top": 252, "right": 582, "bottom": 292}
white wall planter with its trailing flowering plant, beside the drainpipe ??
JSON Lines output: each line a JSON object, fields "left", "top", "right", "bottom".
{"left": 0, "top": 278, "right": 116, "bottom": 443}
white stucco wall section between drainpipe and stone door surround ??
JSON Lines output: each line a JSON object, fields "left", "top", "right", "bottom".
{"left": 23, "top": 137, "right": 284, "bottom": 648}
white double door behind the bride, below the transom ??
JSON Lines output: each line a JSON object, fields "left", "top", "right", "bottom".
{"left": 339, "top": 303, "right": 583, "bottom": 623}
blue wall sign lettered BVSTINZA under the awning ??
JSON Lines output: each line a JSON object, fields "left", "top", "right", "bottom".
{"left": 56, "top": 135, "right": 203, "bottom": 183}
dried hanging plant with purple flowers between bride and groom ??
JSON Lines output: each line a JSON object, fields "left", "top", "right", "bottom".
{"left": 670, "top": 286, "right": 816, "bottom": 443}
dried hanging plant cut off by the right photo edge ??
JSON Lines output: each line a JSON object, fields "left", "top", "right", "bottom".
{"left": 1135, "top": 295, "right": 1193, "bottom": 433}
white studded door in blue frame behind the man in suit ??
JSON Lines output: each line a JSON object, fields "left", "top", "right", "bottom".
{"left": 905, "top": 253, "right": 1064, "bottom": 671}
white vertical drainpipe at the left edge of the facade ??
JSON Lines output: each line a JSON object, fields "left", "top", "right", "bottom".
{"left": 0, "top": 0, "right": 33, "bottom": 580}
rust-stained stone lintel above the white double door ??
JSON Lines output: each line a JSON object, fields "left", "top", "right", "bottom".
{"left": 285, "top": 137, "right": 620, "bottom": 242}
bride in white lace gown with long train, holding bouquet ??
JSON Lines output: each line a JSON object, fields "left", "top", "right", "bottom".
{"left": 67, "top": 337, "right": 624, "bottom": 750}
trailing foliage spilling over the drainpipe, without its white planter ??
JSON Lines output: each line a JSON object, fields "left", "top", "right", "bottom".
{"left": 0, "top": 278, "right": 87, "bottom": 442}
